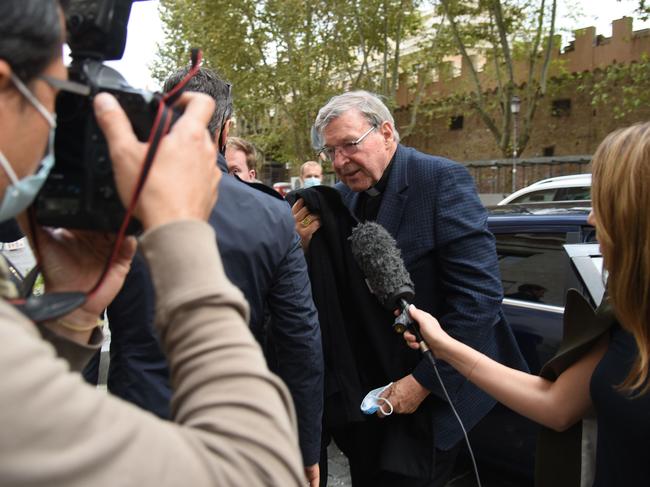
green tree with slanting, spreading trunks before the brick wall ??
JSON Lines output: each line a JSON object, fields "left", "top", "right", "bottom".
{"left": 430, "top": 0, "right": 557, "bottom": 157}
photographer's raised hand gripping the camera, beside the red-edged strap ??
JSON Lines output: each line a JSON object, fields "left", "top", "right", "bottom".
{"left": 94, "top": 93, "right": 221, "bottom": 229}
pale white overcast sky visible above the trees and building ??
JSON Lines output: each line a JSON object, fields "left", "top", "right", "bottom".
{"left": 110, "top": 0, "right": 650, "bottom": 90}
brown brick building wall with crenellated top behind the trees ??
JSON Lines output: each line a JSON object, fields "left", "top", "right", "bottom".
{"left": 396, "top": 17, "right": 650, "bottom": 193}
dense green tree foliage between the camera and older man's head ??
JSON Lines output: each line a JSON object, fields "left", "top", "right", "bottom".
{"left": 155, "top": 0, "right": 419, "bottom": 163}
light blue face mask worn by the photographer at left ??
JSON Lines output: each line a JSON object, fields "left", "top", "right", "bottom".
{"left": 0, "top": 74, "right": 56, "bottom": 222}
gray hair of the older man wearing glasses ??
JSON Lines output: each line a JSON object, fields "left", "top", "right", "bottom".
{"left": 312, "top": 90, "right": 399, "bottom": 144}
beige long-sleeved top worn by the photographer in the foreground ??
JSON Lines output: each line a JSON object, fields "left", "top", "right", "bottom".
{"left": 0, "top": 221, "right": 304, "bottom": 487}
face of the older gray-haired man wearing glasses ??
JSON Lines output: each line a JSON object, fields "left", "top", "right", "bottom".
{"left": 323, "top": 110, "right": 397, "bottom": 191}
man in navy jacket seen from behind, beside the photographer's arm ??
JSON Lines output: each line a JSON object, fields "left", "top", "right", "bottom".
{"left": 90, "top": 68, "right": 323, "bottom": 486}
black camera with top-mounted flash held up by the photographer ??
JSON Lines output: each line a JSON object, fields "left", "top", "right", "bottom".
{"left": 34, "top": 0, "right": 166, "bottom": 233}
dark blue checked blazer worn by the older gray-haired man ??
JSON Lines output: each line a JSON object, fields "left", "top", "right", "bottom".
{"left": 337, "top": 145, "right": 526, "bottom": 450}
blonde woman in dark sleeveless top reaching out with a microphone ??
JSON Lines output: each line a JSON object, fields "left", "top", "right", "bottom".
{"left": 405, "top": 123, "right": 650, "bottom": 487}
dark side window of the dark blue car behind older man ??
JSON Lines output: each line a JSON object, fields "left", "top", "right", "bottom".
{"left": 495, "top": 233, "right": 568, "bottom": 306}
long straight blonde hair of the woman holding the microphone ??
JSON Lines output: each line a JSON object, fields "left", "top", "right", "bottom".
{"left": 592, "top": 123, "right": 650, "bottom": 394}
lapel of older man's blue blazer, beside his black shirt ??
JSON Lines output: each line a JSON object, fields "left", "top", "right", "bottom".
{"left": 377, "top": 145, "right": 408, "bottom": 239}
